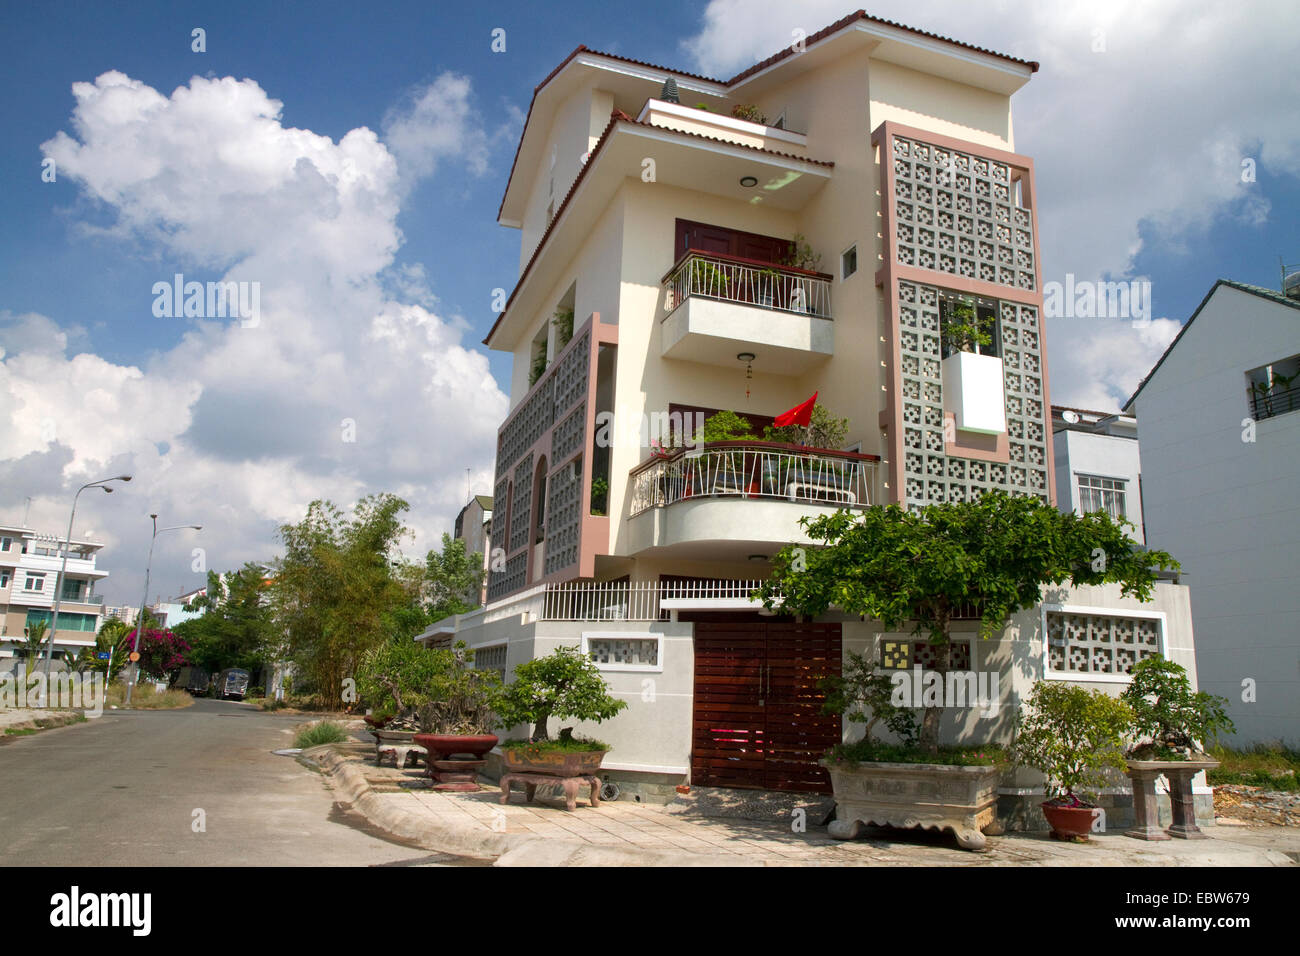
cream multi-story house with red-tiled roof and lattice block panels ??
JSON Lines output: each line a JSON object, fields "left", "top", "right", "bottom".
{"left": 421, "top": 14, "right": 1195, "bottom": 816}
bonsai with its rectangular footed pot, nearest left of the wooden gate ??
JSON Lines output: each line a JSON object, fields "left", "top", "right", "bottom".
{"left": 497, "top": 646, "right": 628, "bottom": 809}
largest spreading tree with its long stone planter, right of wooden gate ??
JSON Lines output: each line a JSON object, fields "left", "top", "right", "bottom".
{"left": 759, "top": 490, "right": 1178, "bottom": 848}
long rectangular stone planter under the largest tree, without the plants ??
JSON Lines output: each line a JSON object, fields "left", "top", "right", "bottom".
{"left": 819, "top": 760, "right": 998, "bottom": 849}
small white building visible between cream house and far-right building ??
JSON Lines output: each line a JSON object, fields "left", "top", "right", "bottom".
{"left": 1052, "top": 405, "right": 1147, "bottom": 544}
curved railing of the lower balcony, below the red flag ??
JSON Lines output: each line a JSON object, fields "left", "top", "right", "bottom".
{"left": 631, "top": 441, "right": 879, "bottom": 515}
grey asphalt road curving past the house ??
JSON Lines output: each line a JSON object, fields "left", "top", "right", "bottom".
{"left": 0, "top": 700, "right": 464, "bottom": 866}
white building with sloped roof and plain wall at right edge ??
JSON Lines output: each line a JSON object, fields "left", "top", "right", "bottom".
{"left": 1125, "top": 278, "right": 1300, "bottom": 744}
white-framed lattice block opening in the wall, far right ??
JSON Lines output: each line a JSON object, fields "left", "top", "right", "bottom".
{"left": 1043, "top": 605, "right": 1165, "bottom": 680}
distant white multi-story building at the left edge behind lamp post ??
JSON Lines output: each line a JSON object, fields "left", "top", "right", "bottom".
{"left": 0, "top": 525, "right": 108, "bottom": 661}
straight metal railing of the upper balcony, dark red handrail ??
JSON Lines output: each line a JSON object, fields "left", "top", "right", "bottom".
{"left": 663, "top": 250, "right": 831, "bottom": 319}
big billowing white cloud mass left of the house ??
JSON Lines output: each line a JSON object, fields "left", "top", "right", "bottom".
{"left": 0, "top": 72, "right": 507, "bottom": 602}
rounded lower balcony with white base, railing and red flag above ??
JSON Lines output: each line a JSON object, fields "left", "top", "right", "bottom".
{"left": 628, "top": 441, "right": 879, "bottom": 561}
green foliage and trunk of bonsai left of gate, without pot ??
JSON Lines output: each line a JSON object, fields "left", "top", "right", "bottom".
{"left": 497, "top": 646, "right": 628, "bottom": 743}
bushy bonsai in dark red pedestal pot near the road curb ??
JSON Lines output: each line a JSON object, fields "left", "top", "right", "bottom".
{"left": 415, "top": 641, "right": 501, "bottom": 791}
